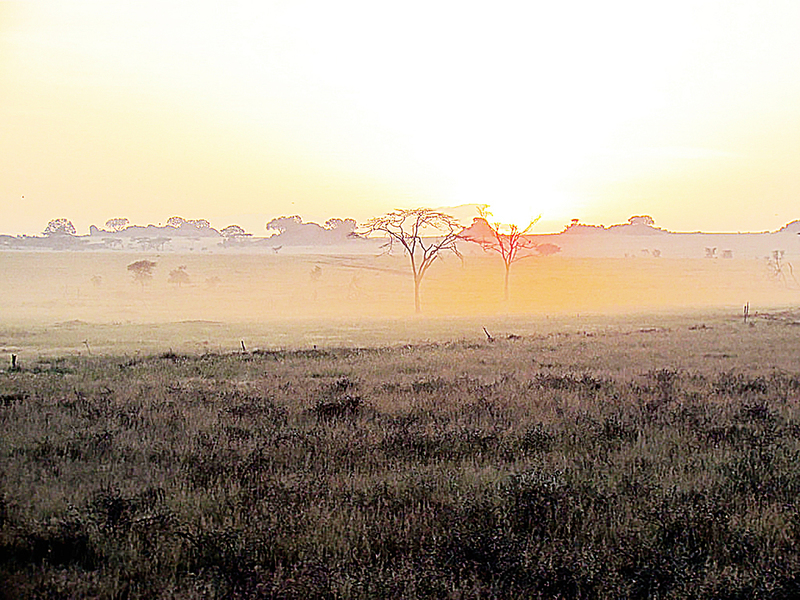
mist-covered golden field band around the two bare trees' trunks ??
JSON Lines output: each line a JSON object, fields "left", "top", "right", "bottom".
{"left": 0, "top": 252, "right": 798, "bottom": 325}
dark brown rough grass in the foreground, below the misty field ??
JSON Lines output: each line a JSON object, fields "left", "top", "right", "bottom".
{"left": 0, "top": 313, "right": 800, "bottom": 598}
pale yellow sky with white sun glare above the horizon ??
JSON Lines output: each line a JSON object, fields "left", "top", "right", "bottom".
{"left": 0, "top": 0, "right": 800, "bottom": 234}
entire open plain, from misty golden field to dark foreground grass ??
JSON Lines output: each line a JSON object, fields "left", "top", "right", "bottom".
{"left": 0, "top": 253, "right": 800, "bottom": 598}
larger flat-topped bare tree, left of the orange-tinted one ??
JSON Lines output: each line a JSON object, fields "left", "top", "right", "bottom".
{"left": 363, "top": 208, "right": 463, "bottom": 313}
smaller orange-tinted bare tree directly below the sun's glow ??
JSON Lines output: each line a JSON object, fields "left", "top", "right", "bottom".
{"left": 461, "top": 206, "right": 560, "bottom": 301}
